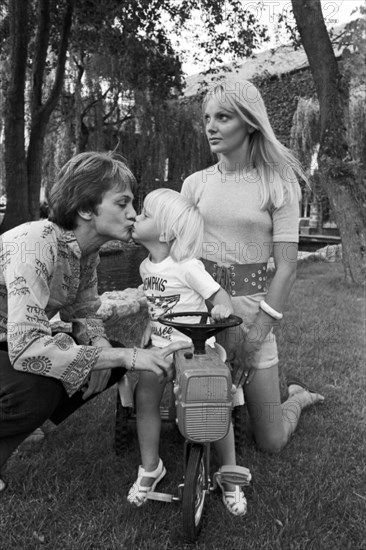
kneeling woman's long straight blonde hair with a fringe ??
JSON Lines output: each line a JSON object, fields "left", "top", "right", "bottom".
{"left": 203, "top": 80, "right": 307, "bottom": 210}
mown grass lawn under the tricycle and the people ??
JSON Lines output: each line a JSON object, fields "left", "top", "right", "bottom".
{"left": 0, "top": 263, "right": 366, "bottom": 550}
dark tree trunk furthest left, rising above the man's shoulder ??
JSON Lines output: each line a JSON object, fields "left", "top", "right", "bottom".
{"left": 1, "top": 0, "right": 30, "bottom": 232}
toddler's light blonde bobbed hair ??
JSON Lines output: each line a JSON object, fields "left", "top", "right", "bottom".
{"left": 144, "top": 189, "right": 203, "bottom": 262}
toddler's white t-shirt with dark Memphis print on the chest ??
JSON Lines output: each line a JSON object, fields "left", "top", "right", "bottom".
{"left": 140, "top": 256, "right": 220, "bottom": 348}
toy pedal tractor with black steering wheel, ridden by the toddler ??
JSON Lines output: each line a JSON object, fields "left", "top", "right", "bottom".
{"left": 115, "top": 312, "right": 251, "bottom": 541}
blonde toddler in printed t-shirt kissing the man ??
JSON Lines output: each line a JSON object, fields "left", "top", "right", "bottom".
{"left": 127, "top": 189, "right": 247, "bottom": 516}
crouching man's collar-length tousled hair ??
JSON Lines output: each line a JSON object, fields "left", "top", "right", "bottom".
{"left": 49, "top": 151, "right": 137, "bottom": 230}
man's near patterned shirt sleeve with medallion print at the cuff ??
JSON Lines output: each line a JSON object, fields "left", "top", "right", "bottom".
{"left": 1, "top": 227, "right": 100, "bottom": 396}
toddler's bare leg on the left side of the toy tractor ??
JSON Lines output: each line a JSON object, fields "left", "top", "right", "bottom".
{"left": 136, "top": 371, "right": 164, "bottom": 487}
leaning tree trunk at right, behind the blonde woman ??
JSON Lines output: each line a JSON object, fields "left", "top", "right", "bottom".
{"left": 292, "top": 0, "right": 366, "bottom": 284}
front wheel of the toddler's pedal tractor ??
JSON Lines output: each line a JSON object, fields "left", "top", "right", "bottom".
{"left": 182, "top": 444, "right": 206, "bottom": 541}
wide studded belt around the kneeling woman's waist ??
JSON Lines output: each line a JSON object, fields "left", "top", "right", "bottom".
{"left": 201, "top": 258, "right": 267, "bottom": 296}
